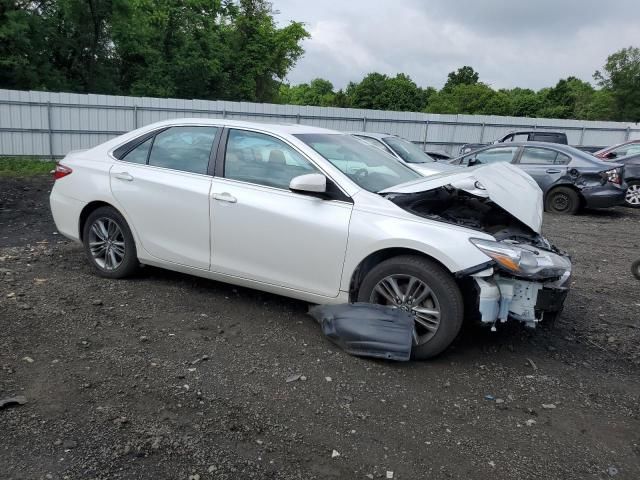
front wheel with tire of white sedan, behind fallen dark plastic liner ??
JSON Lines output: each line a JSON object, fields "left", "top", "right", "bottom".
{"left": 357, "top": 255, "right": 464, "bottom": 360}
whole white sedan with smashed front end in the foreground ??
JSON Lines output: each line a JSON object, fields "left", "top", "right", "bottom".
{"left": 51, "top": 119, "right": 571, "bottom": 358}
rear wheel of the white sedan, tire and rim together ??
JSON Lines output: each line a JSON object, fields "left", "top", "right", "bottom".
{"left": 82, "top": 207, "right": 139, "bottom": 278}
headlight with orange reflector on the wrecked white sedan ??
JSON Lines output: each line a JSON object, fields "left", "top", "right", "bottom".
{"left": 470, "top": 238, "right": 571, "bottom": 279}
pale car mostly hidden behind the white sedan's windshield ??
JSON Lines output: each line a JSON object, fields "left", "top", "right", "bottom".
{"left": 351, "top": 132, "right": 458, "bottom": 177}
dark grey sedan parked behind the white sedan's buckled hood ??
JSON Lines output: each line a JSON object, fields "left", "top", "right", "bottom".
{"left": 450, "top": 142, "right": 626, "bottom": 215}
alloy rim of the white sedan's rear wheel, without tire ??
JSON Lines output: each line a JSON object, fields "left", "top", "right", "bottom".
{"left": 89, "top": 217, "right": 125, "bottom": 271}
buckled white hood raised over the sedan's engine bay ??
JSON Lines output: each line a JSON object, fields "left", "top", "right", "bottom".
{"left": 378, "top": 162, "right": 543, "bottom": 233}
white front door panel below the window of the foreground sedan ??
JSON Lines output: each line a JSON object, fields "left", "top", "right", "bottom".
{"left": 211, "top": 177, "right": 352, "bottom": 297}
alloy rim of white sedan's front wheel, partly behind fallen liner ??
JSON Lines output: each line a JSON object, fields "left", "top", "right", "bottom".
{"left": 369, "top": 274, "right": 441, "bottom": 345}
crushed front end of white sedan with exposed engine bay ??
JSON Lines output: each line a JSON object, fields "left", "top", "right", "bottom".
{"left": 381, "top": 163, "right": 571, "bottom": 329}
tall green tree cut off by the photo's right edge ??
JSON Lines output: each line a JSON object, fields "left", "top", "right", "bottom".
{"left": 593, "top": 47, "right": 640, "bottom": 123}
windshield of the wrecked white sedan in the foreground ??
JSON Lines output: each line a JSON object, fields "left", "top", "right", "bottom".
{"left": 295, "top": 133, "right": 422, "bottom": 192}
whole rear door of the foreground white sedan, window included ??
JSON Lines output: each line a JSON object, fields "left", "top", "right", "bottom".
{"left": 110, "top": 125, "right": 221, "bottom": 269}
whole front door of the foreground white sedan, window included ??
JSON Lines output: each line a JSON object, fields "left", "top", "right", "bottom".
{"left": 211, "top": 129, "right": 352, "bottom": 297}
